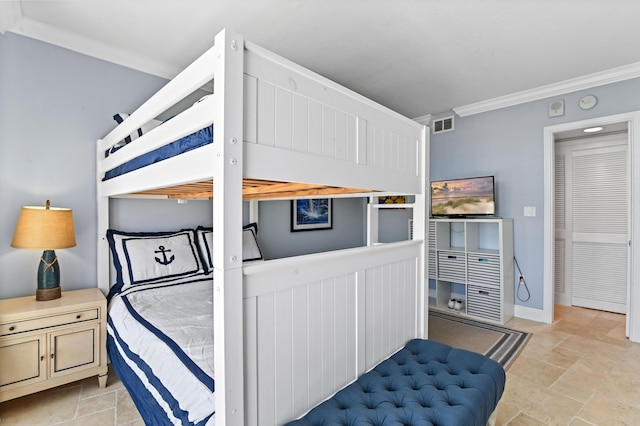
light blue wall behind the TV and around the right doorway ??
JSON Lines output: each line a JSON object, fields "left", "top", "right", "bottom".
{"left": 430, "top": 79, "right": 640, "bottom": 309}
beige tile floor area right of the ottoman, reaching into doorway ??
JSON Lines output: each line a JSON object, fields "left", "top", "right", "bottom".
{"left": 496, "top": 306, "right": 640, "bottom": 426}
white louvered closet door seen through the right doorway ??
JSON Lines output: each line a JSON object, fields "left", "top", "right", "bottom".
{"left": 555, "top": 134, "right": 629, "bottom": 313}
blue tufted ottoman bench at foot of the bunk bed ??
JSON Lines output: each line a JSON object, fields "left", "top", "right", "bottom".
{"left": 289, "top": 339, "right": 505, "bottom": 426}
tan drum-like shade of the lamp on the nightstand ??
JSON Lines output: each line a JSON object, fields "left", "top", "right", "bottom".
{"left": 11, "top": 201, "right": 76, "bottom": 250}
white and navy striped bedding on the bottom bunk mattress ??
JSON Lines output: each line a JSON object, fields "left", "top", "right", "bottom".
{"left": 107, "top": 275, "right": 215, "bottom": 425}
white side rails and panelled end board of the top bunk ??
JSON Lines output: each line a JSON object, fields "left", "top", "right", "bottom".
{"left": 97, "top": 30, "right": 426, "bottom": 200}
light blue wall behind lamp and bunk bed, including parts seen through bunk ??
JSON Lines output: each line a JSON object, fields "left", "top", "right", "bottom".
{"left": 0, "top": 33, "right": 406, "bottom": 299}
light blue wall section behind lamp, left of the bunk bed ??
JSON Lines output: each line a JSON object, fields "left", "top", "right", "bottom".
{"left": 0, "top": 33, "right": 165, "bottom": 298}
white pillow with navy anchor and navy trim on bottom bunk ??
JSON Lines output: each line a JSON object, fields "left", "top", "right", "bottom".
{"left": 107, "top": 229, "right": 204, "bottom": 292}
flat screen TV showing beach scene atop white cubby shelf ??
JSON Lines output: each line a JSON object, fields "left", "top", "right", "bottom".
{"left": 431, "top": 176, "right": 496, "bottom": 217}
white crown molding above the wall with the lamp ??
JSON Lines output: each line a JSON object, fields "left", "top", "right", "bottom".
{"left": 6, "top": 16, "right": 182, "bottom": 79}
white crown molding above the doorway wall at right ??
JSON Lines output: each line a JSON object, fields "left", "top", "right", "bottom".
{"left": 453, "top": 62, "right": 640, "bottom": 117}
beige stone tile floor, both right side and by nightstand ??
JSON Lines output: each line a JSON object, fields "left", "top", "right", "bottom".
{"left": 0, "top": 306, "right": 640, "bottom": 426}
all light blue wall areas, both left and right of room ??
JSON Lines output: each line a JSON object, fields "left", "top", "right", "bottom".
{"left": 6, "top": 33, "right": 640, "bottom": 309}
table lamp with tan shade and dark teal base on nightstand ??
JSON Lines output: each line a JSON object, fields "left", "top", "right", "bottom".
{"left": 11, "top": 200, "right": 76, "bottom": 300}
